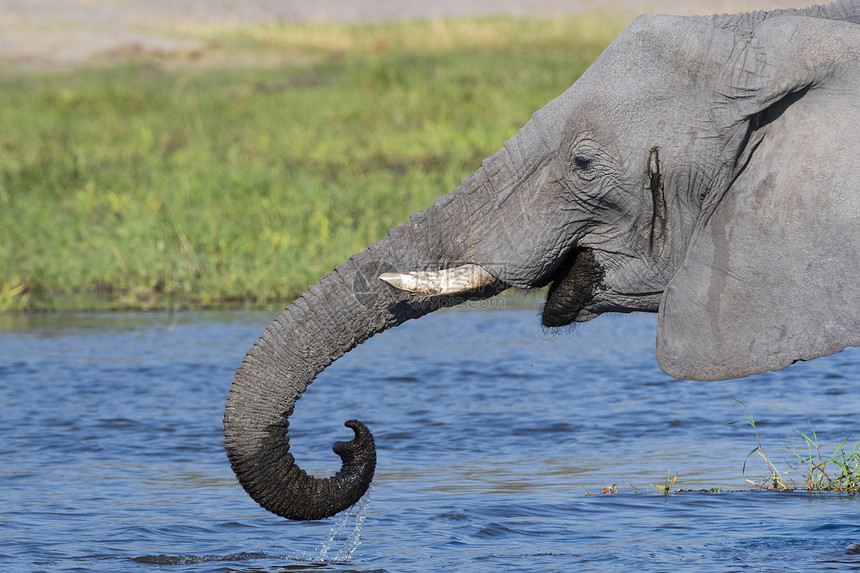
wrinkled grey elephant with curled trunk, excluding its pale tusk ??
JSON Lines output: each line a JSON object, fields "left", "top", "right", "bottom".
{"left": 224, "top": 0, "right": 860, "bottom": 519}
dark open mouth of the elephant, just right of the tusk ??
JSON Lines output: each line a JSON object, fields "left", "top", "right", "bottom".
{"left": 541, "top": 249, "right": 604, "bottom": 327}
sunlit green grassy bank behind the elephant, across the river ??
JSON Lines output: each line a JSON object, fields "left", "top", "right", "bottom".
{"left": 0, "top": 16, "right": 621, "bottom": 312}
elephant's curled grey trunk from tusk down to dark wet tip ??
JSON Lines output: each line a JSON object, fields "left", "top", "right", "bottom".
{"left": 224, "top": 229, "right": 502, "bottom": 519}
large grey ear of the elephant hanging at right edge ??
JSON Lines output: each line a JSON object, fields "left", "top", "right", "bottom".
{"left": 657, "top": 18, "right": 860, "bottom": 380}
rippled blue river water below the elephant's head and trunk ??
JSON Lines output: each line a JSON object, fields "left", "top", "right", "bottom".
{"left": 0, "top": 299, "right": 860, "bottom": 572}
